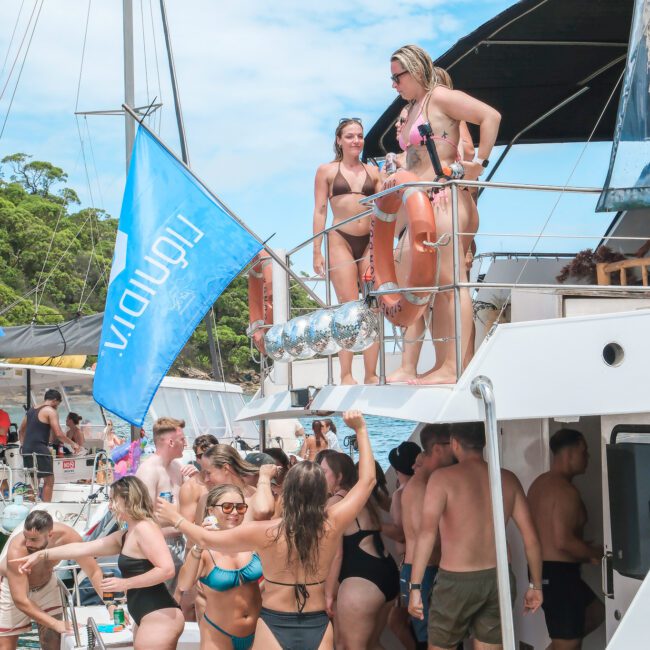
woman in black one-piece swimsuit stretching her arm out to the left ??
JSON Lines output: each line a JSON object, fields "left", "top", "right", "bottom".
{"left": 12, "top": 476, "right": 185, "bottom": 650}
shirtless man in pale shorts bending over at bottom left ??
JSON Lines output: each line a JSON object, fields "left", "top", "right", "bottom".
{"left": 0, "top": 510, "right": 108, "bottom": 650}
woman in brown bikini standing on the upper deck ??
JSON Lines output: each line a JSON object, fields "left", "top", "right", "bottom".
{"left": 314, "top": 117, "right": 381, "bottom": 384}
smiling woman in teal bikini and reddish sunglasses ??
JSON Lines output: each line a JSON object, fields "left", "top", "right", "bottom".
{"left": 178, "top": 484, "right": 262, "bottom": 650}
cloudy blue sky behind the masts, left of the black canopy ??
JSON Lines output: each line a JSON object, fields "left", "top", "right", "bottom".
{"left": 0, "top": 0, "right": 506, "bottom": 264}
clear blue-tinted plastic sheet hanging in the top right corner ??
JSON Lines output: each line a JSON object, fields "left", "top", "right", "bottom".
{"left": 596, "top": 0, "right": 650, "bottom": 212}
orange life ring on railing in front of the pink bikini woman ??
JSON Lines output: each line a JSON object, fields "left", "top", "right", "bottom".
{"left": 370, "top": 170, "right": 437, "bottom": 327}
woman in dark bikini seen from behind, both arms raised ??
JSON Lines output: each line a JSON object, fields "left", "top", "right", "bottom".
{"left": 156, "top": 411, "right": 375, "bottom": 650}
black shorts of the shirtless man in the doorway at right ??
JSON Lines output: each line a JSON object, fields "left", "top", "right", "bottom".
{"left": 542, "top": 562, "right": 596, "bottom": 639}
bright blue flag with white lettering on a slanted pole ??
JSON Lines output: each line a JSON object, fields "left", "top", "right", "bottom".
{"left": 93, "top": 127, "right": 262, "bottom": 426}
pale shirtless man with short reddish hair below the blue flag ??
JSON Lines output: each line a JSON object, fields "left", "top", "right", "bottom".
{"left": 135, "top": 417, "right": 197, "bottom": 593}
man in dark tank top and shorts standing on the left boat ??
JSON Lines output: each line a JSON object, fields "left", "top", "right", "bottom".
{"left": 18, "top": 388, "right": 80, "bottom": 501}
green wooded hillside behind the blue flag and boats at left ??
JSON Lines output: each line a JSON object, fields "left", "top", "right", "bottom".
{"left": 0, "top": 153, "right": 315, "bottom": 381}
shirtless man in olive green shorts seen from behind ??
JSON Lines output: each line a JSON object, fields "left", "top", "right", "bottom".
{"left": 409, "top": 422, "right": 542, "bottom": 650}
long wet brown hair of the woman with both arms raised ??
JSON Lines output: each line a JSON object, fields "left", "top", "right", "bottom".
{"left": 276, "top": 461, "right": 327, "bottom": 575}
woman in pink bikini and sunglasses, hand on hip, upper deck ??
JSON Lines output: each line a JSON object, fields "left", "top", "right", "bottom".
{"left": 390, "top": 45, "right": 501, "bottom": 384}
